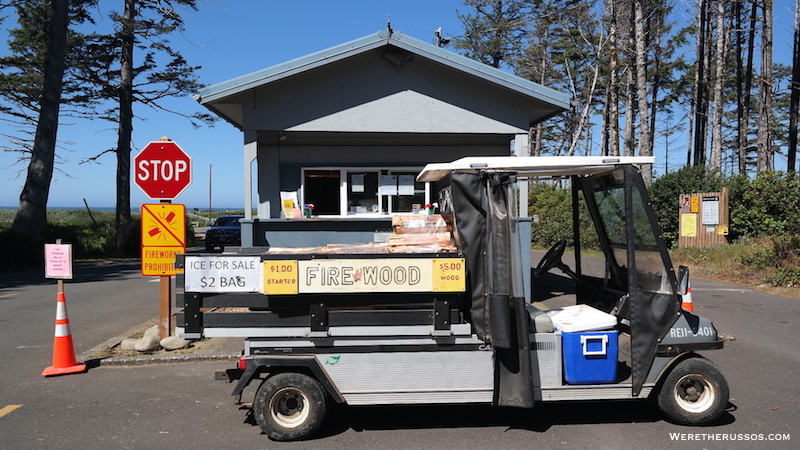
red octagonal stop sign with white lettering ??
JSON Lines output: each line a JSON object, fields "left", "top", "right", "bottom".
{"left": 133, "top": 141, "right": 192, "bottom": 199}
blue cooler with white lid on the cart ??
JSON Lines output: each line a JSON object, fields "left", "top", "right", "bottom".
{"left": 551, "top": 305, "right": 619, "bottom": 384}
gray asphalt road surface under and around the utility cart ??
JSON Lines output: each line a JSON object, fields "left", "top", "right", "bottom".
{"left": 0, "top": 256, "right": 800, "bottom": 450}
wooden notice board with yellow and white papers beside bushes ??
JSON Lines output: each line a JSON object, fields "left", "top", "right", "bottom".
{"left": 678, "top": 188, "right": 730, "bottom": 248}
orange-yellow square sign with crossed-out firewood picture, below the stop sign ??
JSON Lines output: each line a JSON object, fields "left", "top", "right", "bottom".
{"left": 142, "top": 203, "right": 186, "bottom": 247}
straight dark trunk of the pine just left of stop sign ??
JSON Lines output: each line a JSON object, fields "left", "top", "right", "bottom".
{"left": 115, "top": 0, "right": 136, "bottom": 251}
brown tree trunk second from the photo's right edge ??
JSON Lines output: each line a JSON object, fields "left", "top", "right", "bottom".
{"left": 756, "top": 0, "right": 772, "bottom": 173}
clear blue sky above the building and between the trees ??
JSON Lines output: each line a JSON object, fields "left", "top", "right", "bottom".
{"left": 0, "top": 0, "right": 793, "bottom": 209}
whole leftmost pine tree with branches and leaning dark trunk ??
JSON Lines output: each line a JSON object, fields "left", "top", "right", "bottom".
{"left": 0, "top": 0, "right": 90, "bottom": 240}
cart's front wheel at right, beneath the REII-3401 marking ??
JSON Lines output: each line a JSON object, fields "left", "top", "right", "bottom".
{"left": 658, "top": 358, "right": 729, "bottom": 425}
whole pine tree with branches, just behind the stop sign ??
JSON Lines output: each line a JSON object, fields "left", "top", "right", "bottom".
{"left": 77, "top": 0, "right": 214, "bottom": 250}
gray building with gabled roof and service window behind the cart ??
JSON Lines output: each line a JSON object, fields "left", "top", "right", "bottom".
{"left": 197, "top": 30, "right": 570, "bottom": 247}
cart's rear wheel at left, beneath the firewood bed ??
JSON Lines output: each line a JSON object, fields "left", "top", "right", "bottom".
{"left": 253, "top": 372, "right": 327, "bottom": 441}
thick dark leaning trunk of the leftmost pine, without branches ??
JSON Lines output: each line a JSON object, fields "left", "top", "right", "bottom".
{"left": 11, "top": 0, "right": 69, "bottom": 239}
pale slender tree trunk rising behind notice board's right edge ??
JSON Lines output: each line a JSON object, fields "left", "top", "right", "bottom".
{"left": 709, "top": 0, "right": 728, "bottom": 173}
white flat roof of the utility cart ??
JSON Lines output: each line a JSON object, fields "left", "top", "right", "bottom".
{"left": 417, "top": 156, "right": 656, "bottom": 181}
